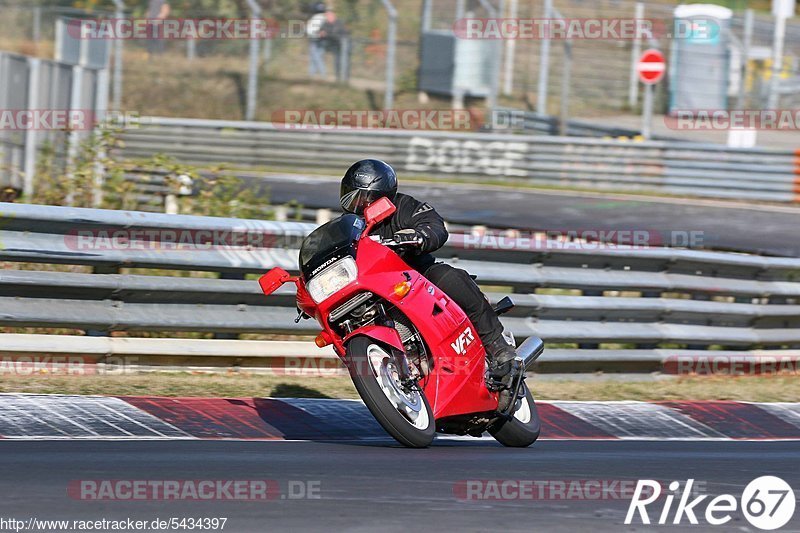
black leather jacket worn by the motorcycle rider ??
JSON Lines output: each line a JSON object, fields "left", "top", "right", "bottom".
{"left": 372, "top": 193, "right": 449, "bottom": 272}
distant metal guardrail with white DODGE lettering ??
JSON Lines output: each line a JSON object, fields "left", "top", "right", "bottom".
{"left": 116, "top": 117, "right": 800, "bottom": 202}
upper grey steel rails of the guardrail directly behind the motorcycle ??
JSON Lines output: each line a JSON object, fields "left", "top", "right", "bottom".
{"left": 0, "top": 204, "right": 800, "bottom": 372}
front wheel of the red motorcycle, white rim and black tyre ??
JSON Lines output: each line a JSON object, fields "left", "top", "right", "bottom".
{"left": 346, "top": 336, "right": 436, "bottom": 448}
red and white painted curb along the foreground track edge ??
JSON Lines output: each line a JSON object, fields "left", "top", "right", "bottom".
{"left": 0, "top": 394, "right": 800, "bottom": 440}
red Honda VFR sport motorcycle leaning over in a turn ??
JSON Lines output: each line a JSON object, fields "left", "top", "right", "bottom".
{"left": 259, "top": 198, "right": 544, "bottom": 448}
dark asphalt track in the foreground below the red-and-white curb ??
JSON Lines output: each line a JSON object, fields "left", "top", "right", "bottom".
{"left": 0, "top": 440, "right": 800, "bottom": 532}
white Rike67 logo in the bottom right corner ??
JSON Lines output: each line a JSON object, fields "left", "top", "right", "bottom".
{"left": 625, "top": 476, "right": 795, "bottom": 531}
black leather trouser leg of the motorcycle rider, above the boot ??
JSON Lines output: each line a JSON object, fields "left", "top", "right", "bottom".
{"left": 421, "top": 263, "right": 503, "bottom": 346}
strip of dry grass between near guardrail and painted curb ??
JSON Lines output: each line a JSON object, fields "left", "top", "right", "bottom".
{"left": 0, "top": 372, "right": 800, "bottom": 402}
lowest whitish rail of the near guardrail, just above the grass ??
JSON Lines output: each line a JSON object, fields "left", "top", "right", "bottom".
{"left": 0, "top": 333, "right": 800, "bottom": 376}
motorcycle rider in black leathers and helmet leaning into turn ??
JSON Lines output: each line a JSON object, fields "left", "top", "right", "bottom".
{"left": 341, "top": 159, "right": 516, "bottom": 387}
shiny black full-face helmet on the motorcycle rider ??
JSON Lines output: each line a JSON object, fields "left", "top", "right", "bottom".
{"left": 341, "top": 159, "right": 397, "bottom": 215}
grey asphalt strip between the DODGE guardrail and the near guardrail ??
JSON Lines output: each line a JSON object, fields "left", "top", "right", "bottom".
{"left": 252, "top": 174, "right": 800, "bottom": 257}
